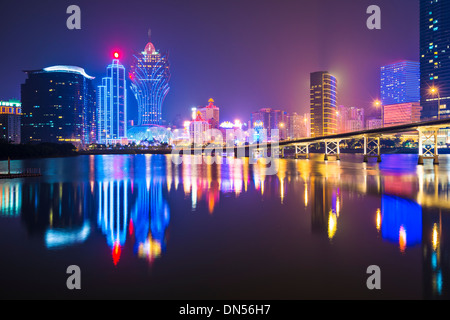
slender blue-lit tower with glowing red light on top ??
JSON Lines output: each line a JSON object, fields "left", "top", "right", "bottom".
{"left": 97, "top": 52, "right": 127, "bottom": 143}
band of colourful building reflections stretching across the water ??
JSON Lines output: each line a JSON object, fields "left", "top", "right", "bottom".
{"left": 0, "top": 156, "right": 450, "bottom": 298}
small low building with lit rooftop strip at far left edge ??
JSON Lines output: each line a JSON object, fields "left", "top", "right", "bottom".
{"left": 0, "top": 100, "right": 22, "bottom": 143}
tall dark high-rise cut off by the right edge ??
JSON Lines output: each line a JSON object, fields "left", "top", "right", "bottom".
{"left": 420, "top": 0, "right": 450, "bottom": 120}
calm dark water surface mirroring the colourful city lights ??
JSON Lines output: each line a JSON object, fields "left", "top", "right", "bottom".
{"left": 0, "top": 155, "right": 450, "bottom": 299}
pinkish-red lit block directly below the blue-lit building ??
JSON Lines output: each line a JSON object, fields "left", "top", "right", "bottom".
{"left": 383, "top": 102, "right": 422, "bottom": 127}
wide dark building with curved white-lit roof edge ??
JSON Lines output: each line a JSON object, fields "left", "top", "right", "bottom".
{"left": 21, "top": 66, "right": 97, "bottom": 146}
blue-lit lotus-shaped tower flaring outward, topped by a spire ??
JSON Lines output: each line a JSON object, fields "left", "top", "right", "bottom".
{"left": 130, "top": 31, "right": 170, "bottom": 126}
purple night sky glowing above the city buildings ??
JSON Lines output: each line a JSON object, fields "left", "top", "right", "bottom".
{"left": 0, "top": 0, "right": 419, "bottom": 121}
